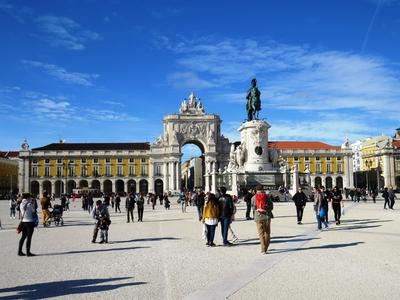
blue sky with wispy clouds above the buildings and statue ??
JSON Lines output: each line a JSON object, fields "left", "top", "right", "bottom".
{"left": 0, "top": 0, "right": 400, "bottom": 158}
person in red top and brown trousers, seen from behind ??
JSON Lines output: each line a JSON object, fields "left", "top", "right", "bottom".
{"left": 251, "top": 185, "right": 274, "bottom": 254}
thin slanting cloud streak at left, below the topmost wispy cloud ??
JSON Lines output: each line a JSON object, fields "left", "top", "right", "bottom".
{"left": 22, "top": 60, "right": 100, "bottom": 86}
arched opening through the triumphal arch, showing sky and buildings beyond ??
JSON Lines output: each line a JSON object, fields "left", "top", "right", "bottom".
{"left": 181, "top": 140, "right": 205, "bottom": 191}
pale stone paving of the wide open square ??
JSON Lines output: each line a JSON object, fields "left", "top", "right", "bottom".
{"left": 0, "top": 199, "right": 400, "bottom": 299}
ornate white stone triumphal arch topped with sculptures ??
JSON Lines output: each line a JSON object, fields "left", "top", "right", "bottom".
{"left": 150, "top": 93, "right": 230, "bottom": 192}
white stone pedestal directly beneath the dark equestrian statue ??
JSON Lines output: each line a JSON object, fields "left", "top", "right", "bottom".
{"left": 239, "top": 120, "right": 273, "bottom": 173}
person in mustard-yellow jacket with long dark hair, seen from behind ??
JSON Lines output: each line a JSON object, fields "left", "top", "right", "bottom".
{"left": 201, "top": 194, "right": 219, "bottom": 247}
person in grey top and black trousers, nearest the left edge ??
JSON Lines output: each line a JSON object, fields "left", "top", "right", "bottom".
{"left": 18, "top": 193, "right": 36, "bottom": 256}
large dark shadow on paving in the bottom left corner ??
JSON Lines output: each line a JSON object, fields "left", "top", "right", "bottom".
{"left": 0, "top": 277, "right": 147, "bottom": 299}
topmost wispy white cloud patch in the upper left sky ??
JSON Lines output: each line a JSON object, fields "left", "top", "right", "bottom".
{"left": 35, "top": 15, "right": 101, "bottom": 50}
